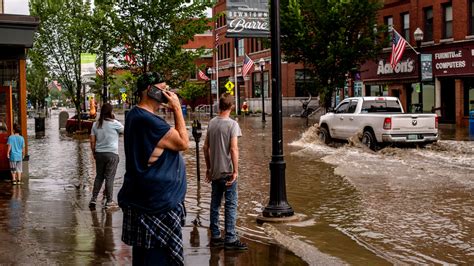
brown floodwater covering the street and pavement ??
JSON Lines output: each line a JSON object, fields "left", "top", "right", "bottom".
{"left": 0, "top": 109, "right": 474, "bottom": 265}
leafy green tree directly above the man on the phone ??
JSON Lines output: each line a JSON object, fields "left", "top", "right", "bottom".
{"left": 104, "top": 0, "right": 212, "bottom": 88}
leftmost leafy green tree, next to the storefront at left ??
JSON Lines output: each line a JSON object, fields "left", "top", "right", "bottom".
{"left": 30, "top": 0, "right": 97, "bottom": 124}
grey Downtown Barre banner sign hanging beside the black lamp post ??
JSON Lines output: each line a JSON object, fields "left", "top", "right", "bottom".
{"left": 226, "top": 0, "right": 270, "bottom": 38}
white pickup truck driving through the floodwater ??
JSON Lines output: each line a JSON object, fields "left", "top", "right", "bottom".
{"left": 319, "top": 97, "right": 438, "bottom": 150}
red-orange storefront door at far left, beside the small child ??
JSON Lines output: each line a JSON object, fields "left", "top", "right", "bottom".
{"left": 0, "top": 86, "right": 13, "bottom": 171}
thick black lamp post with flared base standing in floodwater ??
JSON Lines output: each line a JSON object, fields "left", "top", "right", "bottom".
{"left": 262, "top": 0, "right": 294, "bottom": 218}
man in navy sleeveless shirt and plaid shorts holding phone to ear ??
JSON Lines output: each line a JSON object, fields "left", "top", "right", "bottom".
{"left": 118, "top": 72, "right": 189, "bottom": 265}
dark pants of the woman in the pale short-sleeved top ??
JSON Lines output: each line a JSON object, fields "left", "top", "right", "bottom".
{"left": 92, "top": 152, "right": 119, "bottom": 201}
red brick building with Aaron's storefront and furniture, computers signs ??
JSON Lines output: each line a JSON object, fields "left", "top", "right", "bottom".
{"left": 360, "top": 0, "right": 474, "bottom": 126}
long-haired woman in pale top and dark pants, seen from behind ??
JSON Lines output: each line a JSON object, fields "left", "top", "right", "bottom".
{"left": 89, "top": 103, "right": 123, "bottom": 209}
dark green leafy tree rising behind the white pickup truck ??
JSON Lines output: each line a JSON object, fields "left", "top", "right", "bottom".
{"left": 281, "top": 0, "right": 386, "bottom": 107}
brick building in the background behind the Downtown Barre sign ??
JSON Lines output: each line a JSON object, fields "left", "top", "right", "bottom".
{"left": 212, "top": 0, "right": 311, "bottom": 113}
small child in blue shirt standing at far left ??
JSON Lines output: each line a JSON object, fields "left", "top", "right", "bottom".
{"left": 7, "top": 124, "right": 25, "bottom": 185}
